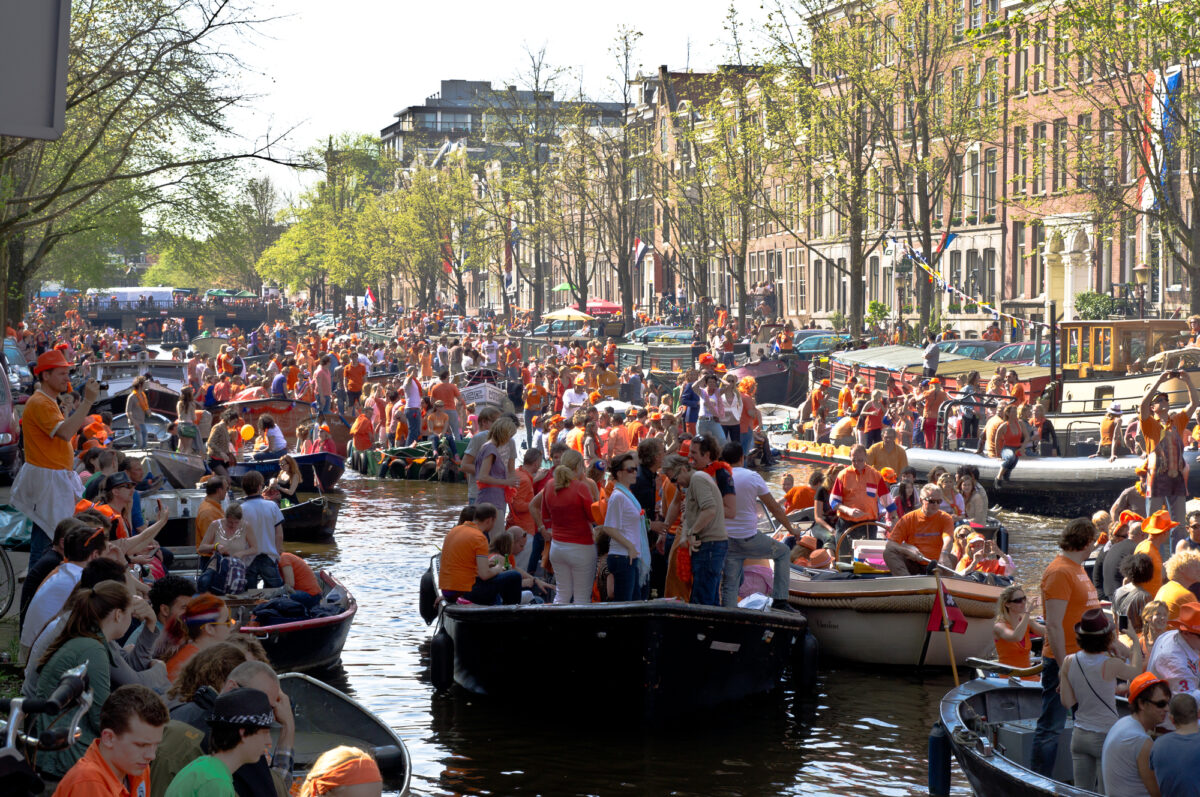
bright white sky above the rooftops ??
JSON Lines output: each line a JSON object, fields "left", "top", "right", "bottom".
{"left": 230, "top": 0, "right": 762, "bottom": 198}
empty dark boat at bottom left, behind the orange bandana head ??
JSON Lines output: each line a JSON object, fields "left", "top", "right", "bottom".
{"left": 280, "top": 672, "right": 413, "bottom": 797}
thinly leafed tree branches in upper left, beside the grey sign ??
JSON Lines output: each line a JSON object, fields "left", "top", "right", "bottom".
{"left": 0, "top": 0, "right": 290, "bottom": 323}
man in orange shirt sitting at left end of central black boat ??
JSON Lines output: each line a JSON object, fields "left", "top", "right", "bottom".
{"left": 438, "top": 503, "right": 521, "bottom": 606}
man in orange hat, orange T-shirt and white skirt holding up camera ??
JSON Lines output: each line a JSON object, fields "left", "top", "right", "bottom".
{"left": 10, "top": 348, "right": 100, "bottom": 562}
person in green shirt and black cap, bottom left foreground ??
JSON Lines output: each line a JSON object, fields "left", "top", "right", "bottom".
{"left": 167, "top": 687, "right": 275, "bottom": 797}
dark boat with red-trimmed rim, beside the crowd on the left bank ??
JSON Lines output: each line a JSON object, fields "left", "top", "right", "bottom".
{"left": 234, "top": 570, "right": 359, "bottom": 672}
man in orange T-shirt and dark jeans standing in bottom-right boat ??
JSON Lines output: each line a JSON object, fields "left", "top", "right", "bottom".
{"left": 1031, "top": 517, "right": 1104, "bottom": 778}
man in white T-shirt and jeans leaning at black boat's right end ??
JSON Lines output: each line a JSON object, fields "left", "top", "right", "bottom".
{"left": 721, "top": 443, "right": 796, "bottom": 611}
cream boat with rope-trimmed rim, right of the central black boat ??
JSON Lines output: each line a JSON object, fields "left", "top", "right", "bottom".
{"left": 788, "top": 567, "right": 1003, "bottom": 667}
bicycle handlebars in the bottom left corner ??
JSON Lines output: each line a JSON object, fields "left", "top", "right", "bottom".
{"left": 0, "top": 663, "right": 94, "bottom": 797}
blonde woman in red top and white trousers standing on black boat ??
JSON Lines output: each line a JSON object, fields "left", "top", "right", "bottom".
{"left": 529, "top": 449, "right": 600, "bottom": 604}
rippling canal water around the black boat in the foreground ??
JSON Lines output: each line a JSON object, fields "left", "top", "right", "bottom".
{"left": 288, "top": 466, "right": 1062, "bottom": 797}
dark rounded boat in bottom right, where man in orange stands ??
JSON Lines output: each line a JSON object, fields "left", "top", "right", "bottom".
{"left": 929, "top": 677, "right": 1099, "bottom": 797}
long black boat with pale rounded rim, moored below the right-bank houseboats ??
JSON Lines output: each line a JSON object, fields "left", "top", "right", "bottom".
{"left": 772, "top": 435, "right": 1200, "bottom": 517}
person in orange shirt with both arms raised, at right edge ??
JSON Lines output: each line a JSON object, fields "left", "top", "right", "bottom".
{"left": 1138, "top": 371, "right": 1198, "bottom": 532}
